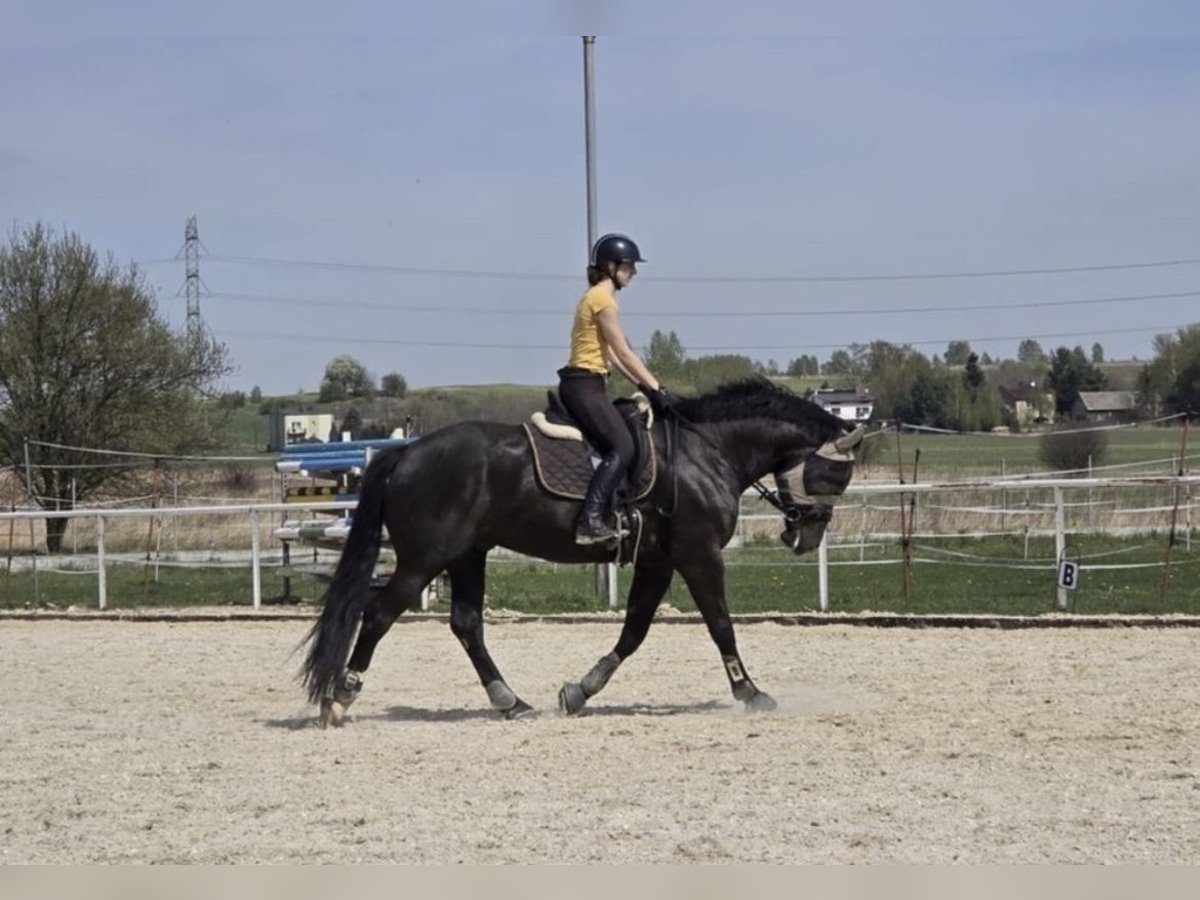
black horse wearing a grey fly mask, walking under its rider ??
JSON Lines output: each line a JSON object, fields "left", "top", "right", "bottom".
{"left": 302, "top": 379, "right": 863, "bottom": 726}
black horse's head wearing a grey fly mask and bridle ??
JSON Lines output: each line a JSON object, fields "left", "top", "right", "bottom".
{"left": 775, "top": 426, "right": 866, "bottom": 553}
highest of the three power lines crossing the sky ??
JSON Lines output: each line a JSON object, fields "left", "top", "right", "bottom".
{"left": 136, "top": 253, "right": 1200, "bottom": 284}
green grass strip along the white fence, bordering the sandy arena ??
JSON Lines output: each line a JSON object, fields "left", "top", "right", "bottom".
{"left": 9, "top": 536, "right": 1200, "bottom": 616}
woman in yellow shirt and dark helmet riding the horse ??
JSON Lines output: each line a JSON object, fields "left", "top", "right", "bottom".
{"left": 558, "top": 234, "right": 671, "bottom": 544}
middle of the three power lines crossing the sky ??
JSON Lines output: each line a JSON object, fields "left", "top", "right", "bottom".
{"left": 210, "top": 290, "right": 1200, "bottom": 319}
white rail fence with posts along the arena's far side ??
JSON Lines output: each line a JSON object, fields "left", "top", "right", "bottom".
{"left": 0, "top": 475, "right": 1200, "bottom": 610}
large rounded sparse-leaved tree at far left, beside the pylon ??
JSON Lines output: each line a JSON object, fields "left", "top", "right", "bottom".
{"left": 0, "top": 223, "right": 229, "bottom": 552}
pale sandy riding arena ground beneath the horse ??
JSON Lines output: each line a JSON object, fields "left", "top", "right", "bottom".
{"left": 0, "top": 620, "right": 1200, "bottom": 863}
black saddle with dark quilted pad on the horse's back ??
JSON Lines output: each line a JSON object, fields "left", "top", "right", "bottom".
{"left": 522, "top": 390, "right": 658, "bottom": 508}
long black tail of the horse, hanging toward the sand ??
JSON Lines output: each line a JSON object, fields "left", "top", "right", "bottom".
{"left": 301, "top": 446, "right": 404, "bottom": 703}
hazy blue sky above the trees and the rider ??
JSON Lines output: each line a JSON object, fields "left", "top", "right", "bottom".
{"left": 0, "top": 4, "right": 1200, "bottom": 392}
